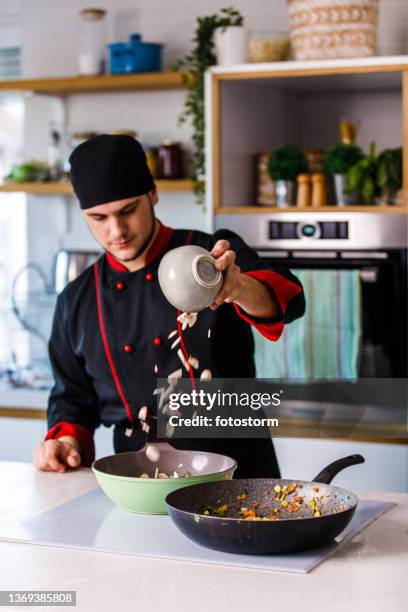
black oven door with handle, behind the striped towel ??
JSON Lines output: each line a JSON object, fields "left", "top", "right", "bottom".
{"left": 258, "top": 249, "right": 408, "bottom": 378}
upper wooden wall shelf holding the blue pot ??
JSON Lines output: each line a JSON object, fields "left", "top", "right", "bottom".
{"left": 0, "top": 72, "right": 184, "bottom": 95}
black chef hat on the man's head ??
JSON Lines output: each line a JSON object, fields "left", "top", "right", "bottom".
{"left": 69, "top": 134, "right": 155, "bottom": 209}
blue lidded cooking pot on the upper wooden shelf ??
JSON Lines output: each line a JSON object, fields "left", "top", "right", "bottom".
{"left": 108, "top": 34, "right": 163, "bottom": 74}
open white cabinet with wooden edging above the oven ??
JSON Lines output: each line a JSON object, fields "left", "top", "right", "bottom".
{"left": 206, "top": 56, "right": 408, "bottom": 215}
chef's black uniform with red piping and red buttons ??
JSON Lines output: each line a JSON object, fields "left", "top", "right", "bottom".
{"left": 46, "top": 224, "right": 304, "bottom": 478}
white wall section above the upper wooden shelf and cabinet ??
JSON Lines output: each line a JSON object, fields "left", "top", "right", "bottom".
{"left": 18, "top": 0, "right": 408, "bottom": 77}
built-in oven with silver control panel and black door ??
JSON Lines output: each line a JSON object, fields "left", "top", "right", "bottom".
{"left": 215, "top": 211, "right": 408, "bottom": 378}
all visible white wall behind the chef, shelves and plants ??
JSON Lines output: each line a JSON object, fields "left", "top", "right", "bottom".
{"left": 17, "top": 0, "right": 408, "bottom": 251}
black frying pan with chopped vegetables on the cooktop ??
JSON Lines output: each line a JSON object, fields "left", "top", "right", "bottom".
{"left": 166, "top": 455, "right": 364, "bottom": 555}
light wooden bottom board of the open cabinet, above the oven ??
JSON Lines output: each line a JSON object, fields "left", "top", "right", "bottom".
{"left": 215, "top": 204, "right": 408, "bottom": 215}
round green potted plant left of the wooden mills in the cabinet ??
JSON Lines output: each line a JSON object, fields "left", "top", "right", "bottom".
{"left": 267, "top": 145, "right": 308, "bottom": 207}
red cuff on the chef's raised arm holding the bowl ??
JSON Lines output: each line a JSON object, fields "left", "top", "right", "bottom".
{"left": 234, "top": 270, "right": 302, "bottom": 341}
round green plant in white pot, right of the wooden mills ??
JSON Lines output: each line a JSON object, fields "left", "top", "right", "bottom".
{"left": 324, "top": 143, "right": 364, "bottom": 206}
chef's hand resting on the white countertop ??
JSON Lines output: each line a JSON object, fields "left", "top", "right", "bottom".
{"left": 33, "top": 436, "right": 81, "bottom": 472}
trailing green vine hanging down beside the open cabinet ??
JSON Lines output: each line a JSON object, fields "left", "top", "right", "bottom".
{"left": 174, "top": 7, "right": 244, "bottom": 204}
